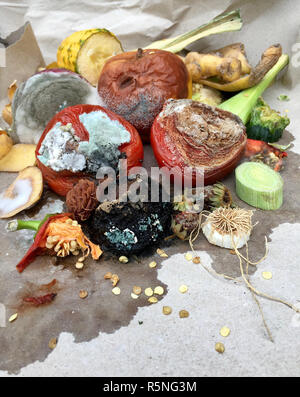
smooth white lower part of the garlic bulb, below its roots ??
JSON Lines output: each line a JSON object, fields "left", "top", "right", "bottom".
{"left": 202, "top": 222, "right": 250, "bottom": 249}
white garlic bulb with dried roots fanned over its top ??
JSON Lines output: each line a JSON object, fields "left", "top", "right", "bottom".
{"left": 202, "top": 207, "right": 253, "bottom": 249}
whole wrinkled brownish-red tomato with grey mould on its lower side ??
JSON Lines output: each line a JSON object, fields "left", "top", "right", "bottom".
{"left": 98, "top": 49, "right": 191, "bottom": 142}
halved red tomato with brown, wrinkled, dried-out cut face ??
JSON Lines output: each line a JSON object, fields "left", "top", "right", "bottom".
{"left": 151, "top": 100, "right": 247, "bottom": 186}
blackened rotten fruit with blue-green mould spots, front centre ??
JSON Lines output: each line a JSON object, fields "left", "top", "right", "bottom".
{"left": 85, "top": 176, "right": 173, "bottom": 255}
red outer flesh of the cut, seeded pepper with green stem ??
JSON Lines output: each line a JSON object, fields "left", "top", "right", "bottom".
{"left": 16, "top": 214, "right": 73, "bottom": 273}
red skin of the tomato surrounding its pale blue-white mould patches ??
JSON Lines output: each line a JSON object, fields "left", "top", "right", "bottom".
{"left": 35, "top": 105, "right": 144, "bottom": 196}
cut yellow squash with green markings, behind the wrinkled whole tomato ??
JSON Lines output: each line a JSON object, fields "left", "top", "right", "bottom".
{"left": 57, "top": 29, "right": 123, "bottom": 86}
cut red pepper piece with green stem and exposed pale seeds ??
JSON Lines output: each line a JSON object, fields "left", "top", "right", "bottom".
{"left": 7, "top": 213, "right": 102, "bottom": 273}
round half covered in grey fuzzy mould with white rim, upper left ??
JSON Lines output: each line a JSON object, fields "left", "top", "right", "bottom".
{"left": 12, "top": 69, "right": 100, "bottom": 144}
